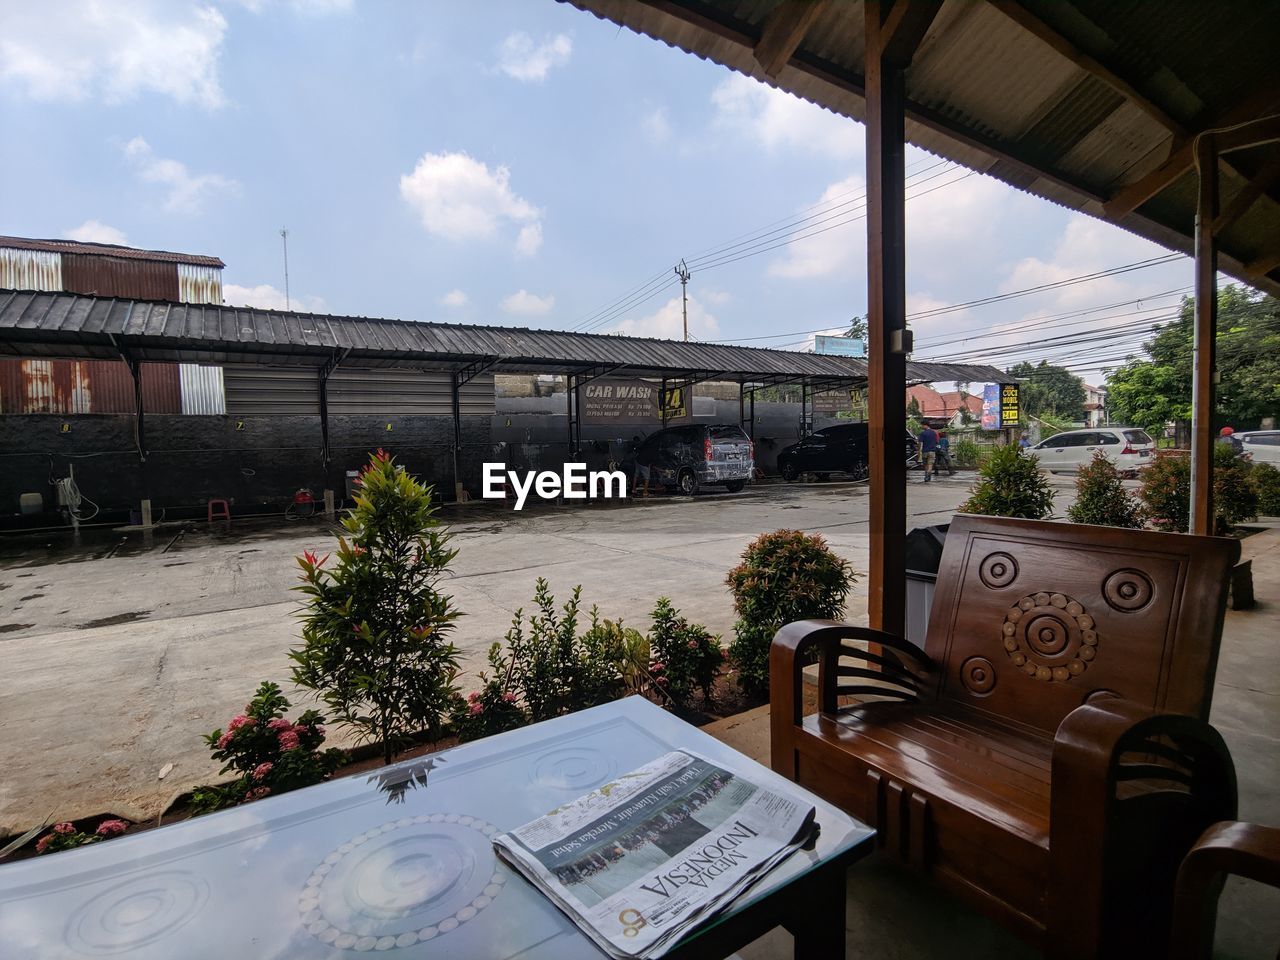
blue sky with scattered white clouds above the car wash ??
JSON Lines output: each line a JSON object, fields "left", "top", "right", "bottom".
{"left": 0, "top": 0, "right": 1193, "bottom": 381}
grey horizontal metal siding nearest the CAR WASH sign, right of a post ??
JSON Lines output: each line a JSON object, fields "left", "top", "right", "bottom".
{"left": 329, "top": 367, "right": 494, "bottom": 416}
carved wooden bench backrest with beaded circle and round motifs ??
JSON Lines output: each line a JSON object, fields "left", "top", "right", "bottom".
{"left": 925, "top": 515, "right": 1240, "bottom": 732}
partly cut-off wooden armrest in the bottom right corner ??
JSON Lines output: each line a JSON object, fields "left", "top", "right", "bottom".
{"left": 1169, "top": 820, "right": 1280, "bottom": 960}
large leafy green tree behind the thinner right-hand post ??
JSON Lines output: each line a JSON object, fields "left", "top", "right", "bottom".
{"left": 1107, "top": 284, "right": 1280, "bottom": 429}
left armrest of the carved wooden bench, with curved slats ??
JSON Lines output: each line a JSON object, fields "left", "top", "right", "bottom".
{"left": 769, "top": 620, "right": 933, "bottom": 778}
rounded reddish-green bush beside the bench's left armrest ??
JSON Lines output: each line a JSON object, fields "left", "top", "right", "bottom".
{"left": 727, "top": 530, "right": 856, "bottom": 695}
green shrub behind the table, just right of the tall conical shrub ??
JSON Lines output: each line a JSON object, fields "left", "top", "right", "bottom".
{"left": 507, "top": 577, "right": 623, "bottom": 722}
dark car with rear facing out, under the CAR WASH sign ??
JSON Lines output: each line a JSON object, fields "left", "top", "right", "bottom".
{"left": 631, "top": 424, "right": 755, "bottom": 497}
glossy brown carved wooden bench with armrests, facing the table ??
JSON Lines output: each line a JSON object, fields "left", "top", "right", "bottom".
{"left": 771, "top": 515, "right": 1239, "bottom": 957}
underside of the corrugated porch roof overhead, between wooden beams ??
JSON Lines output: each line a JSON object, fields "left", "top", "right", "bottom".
{"left": 563, "top": 0, "right": 1280, "bottom": 296}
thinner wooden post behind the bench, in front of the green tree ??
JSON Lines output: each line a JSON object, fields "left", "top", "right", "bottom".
{"left": 1190, "top": 134, "right": 1217, "bottom": 536}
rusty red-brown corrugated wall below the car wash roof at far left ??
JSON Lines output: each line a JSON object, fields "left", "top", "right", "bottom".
{"left": 0, "top": 360, "right": 182, "bottom": 416}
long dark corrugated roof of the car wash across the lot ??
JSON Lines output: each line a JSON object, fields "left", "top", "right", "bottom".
{"left": 0, "top": 291, "right": 1004, "bottom": 383}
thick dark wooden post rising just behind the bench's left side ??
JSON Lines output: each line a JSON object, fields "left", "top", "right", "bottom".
{"left": 865, "top": 0, "right": 923, "bottom": 636}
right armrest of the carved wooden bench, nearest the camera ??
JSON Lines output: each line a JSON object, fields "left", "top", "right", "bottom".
{"left": 1046, "top": 696, "right": 1236, "bottom": 956}
